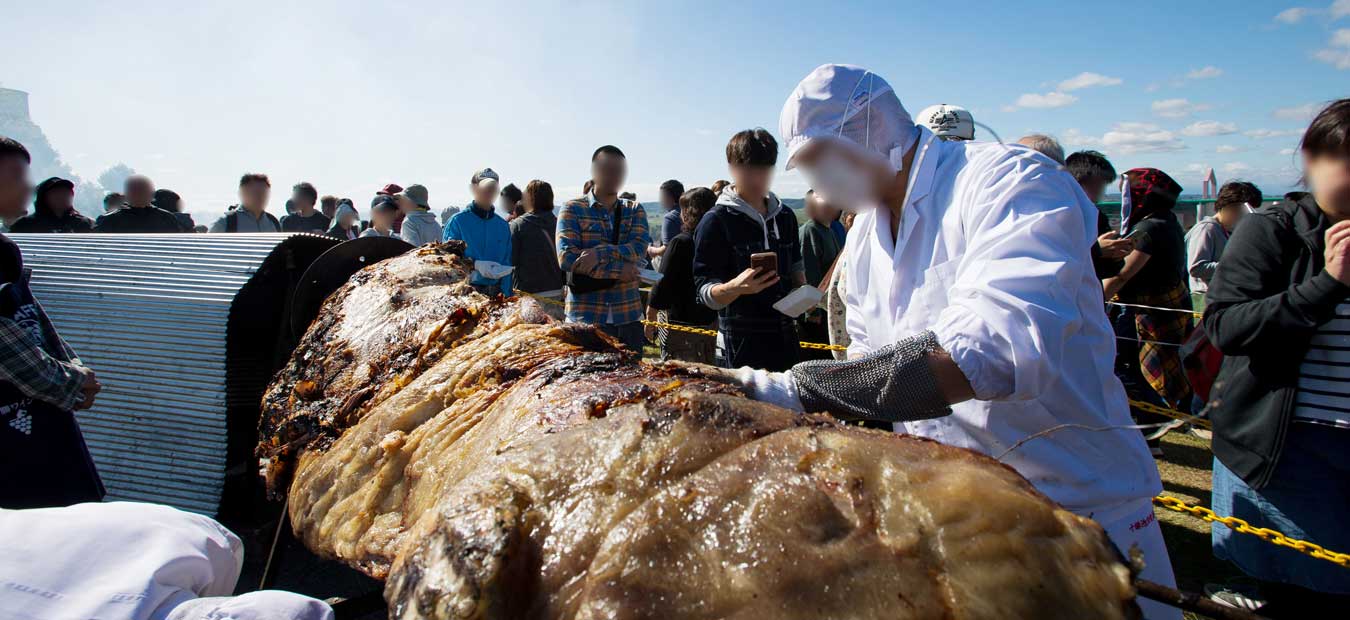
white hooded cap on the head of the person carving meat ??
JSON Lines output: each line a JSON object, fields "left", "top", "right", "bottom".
{"left": 778, "top": 65, "right": 919, "bottom": 170}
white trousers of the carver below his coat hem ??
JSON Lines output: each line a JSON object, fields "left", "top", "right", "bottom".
{"left": 1081, "top": 498, "right": 1181, "bottom": 620}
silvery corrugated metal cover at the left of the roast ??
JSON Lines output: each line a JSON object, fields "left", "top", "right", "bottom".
{"left": 11, "top": 234, "right": 336, "bottom": 515}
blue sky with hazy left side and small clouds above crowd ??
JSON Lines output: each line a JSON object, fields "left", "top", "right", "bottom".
{"left": 0, "top": 0, "right": 1350, "bottom": 221}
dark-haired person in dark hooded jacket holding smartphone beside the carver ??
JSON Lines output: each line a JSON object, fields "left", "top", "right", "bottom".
{"left": 694, "top": 128, "right": 806, "bottom": 370}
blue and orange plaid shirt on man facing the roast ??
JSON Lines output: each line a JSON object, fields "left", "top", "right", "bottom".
{"left": 558, "top": 193, "right": 652, "bottom": 326}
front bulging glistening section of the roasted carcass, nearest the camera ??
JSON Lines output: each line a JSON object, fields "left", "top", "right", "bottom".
{"left": 385, "top": 407, "right": 1135, "bottom": 620}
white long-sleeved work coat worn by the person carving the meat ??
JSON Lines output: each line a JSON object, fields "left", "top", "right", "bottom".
{"left": 842, "top": 134, "right": 1162, "bottom": 511}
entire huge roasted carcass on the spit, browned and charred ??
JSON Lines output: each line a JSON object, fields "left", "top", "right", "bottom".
{"left": 259, "top": 247, "right": 1137, "bottom": 619}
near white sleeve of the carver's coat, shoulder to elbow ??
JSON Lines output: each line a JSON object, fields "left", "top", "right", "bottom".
{"left": 933, "top": 162, "right": 1095, "bottom": 400}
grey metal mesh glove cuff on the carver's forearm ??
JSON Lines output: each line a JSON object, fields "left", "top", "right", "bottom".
{"left": 791, "top": 331, "right": 952, "bottom": 421}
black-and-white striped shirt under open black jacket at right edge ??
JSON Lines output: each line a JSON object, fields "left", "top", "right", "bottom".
{"left": 1293, "top": 303, "right": 1350, "bottom": 427}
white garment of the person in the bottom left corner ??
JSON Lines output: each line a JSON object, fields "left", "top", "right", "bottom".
{"left": 0, "top": 502, "right": 332, "bottom": 620}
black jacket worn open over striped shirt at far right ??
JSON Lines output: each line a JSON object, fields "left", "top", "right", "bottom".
{"left": 1204, "top": 196, "right": 1350, "bottom": 489}
